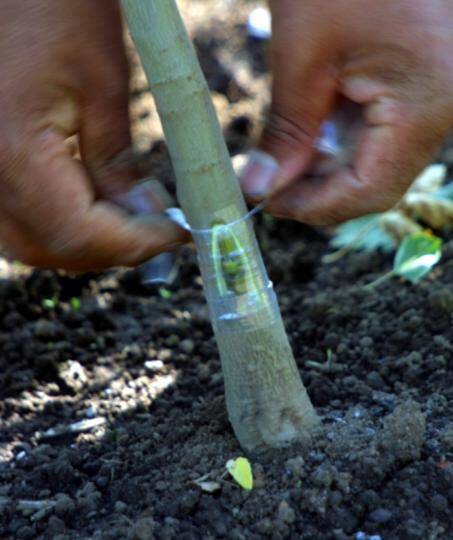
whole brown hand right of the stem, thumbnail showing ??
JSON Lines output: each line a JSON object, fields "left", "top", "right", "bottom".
{"left": 242, "top": 0, "right": 453, "bottom": 224}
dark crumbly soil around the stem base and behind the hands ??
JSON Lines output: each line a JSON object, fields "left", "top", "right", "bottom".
{"left": 0, "top": 0, "right": 453, "bottom": 540}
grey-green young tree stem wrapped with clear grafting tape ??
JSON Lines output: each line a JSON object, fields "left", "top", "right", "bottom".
{"left": 122, "top": 0, "right": 317, "bottom": 451}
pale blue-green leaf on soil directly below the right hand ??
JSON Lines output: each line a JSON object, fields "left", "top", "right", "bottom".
{"left": 331, "top": 214, "right": 395, "bottom": 252}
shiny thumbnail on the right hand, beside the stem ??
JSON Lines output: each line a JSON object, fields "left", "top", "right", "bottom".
{"left": 241, "top": 150, "right": 279, "bottom": 198}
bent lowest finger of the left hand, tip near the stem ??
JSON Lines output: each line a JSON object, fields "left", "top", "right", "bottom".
{"left": 0, "top": 131, "right": 186, "bottom": 270}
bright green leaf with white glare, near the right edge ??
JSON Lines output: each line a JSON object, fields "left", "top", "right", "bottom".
{"left": 393, "top": 233, "right": 442, "bottom": 283}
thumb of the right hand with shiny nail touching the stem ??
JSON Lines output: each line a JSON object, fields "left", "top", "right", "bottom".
{"left": 241, "top": 35, "right": 336, "bottom": 200}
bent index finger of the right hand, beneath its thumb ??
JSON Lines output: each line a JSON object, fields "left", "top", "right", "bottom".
{"left": 269, "top": 98, "right": 442, "bottom": 225}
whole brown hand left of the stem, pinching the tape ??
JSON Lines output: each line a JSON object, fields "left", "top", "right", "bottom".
{"left": 0, "top": 0, "right": 185, "bottom": 270}
